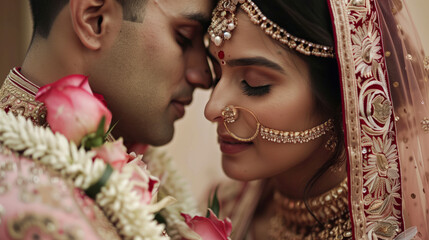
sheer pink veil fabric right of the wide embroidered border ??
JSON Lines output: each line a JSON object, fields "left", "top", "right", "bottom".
{"left": 378, "top": 1, "right": 429, "bottom": 239}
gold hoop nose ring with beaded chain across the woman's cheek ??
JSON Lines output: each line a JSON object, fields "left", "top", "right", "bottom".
{"left": 222, "top": 105, "right": 334, "bottom": 143}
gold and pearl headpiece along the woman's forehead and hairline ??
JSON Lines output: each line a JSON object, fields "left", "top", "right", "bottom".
{"left": 208, "top": 0, "right": 335, "bottom": 58}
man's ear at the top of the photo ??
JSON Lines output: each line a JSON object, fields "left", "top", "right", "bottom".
{"left": 70, "top": 0, "right": 122, "bottom": 50}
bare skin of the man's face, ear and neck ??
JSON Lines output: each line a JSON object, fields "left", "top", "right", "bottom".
{"left": 22, "top": 0, "right": 212, "bottom": 145}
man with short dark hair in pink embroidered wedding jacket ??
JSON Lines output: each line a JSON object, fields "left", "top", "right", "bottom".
{"left": 0, "top": 0, "right": 213, "bottom": 239}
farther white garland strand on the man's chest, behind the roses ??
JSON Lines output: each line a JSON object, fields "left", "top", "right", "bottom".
{"left": 143, "top": 148, "right": 201, "bottom": 240}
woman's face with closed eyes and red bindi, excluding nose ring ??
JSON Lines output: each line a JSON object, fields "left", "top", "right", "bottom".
{"left": 205, "top": 10, "right": 328, "bottom": 180}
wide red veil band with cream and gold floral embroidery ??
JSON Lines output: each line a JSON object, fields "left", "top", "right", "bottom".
{"left": 338, "top": 0, "right": 404, "bottom": 239}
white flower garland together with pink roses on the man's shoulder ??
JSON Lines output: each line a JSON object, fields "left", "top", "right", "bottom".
{"left": 0, "top": 75, "right": 174, "bottom": 239}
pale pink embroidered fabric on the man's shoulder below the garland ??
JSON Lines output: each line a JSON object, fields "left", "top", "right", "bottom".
{"left": 0, "top": 153, "right": 114, "bottom": 240}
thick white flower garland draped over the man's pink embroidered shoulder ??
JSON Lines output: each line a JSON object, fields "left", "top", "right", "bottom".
{"left": 0, "top": 110, "right": 171, "bottom": 240}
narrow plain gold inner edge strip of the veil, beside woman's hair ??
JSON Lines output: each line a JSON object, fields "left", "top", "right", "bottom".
{"left": 329, "top": 0, "right": 367, "bottom": 239}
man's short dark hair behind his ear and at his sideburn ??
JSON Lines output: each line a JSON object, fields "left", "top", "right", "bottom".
{"left": 29, "top": 0, "right": 147, "bottom": 38}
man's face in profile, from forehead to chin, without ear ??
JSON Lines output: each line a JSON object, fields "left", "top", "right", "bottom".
{"left": 94, "top": 0, "right": 212, "bottom": 145}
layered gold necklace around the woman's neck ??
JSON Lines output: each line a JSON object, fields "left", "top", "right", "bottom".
{"left": 269, "top": 178, "right": 352, "bottom": 240}
